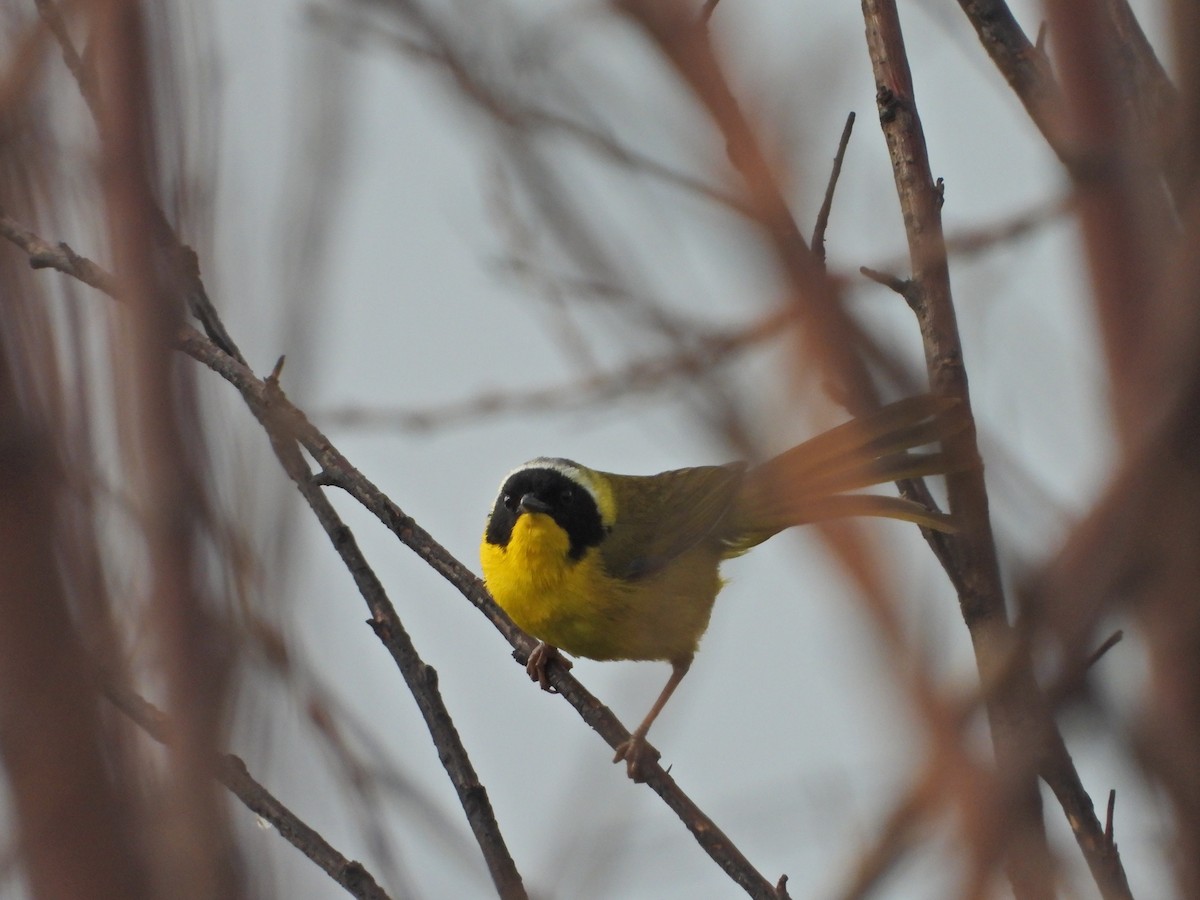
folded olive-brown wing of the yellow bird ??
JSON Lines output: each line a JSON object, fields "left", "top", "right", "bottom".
{"left": 600, "top": 463, "right": 745, "bottom": 580}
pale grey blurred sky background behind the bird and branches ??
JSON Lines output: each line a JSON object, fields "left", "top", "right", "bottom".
{"left": 0, "top": 0, "right": 1182, "bottom": 899}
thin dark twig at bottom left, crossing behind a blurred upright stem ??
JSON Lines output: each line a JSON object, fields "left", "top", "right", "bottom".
{"left": 104, "top": 682, "right": 388, "bottom": 900}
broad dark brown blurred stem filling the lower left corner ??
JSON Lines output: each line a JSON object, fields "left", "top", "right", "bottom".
{"left": 0, "top": 301, "right": 154, "bottom": 900}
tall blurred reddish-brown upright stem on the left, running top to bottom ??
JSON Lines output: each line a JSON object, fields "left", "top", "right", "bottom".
{"left": 88, "top": 4, "right": 246, "bottom": 900}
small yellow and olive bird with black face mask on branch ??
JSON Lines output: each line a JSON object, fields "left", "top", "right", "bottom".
{"left": 480, "top": 395, "right": 966, "bottom": 781}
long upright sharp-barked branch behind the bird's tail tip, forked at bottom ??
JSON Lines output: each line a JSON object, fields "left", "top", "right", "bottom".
{"left": 863, "top": 0, "right": 1129, "bottom": 898}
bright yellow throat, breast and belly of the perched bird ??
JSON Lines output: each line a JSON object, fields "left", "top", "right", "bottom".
{"left": 480, "top": 514, "right": 721, "bottom": 660}
